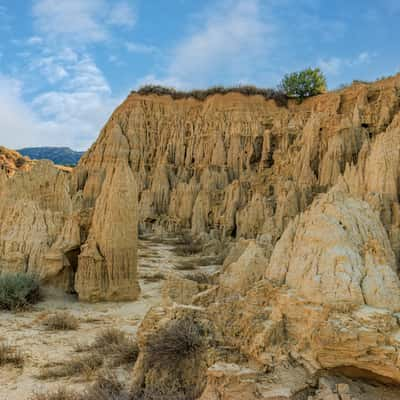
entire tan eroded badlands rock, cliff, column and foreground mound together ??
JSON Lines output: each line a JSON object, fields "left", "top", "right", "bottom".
{"left": 0, "top": 75, "right": 400, "bottom": 400}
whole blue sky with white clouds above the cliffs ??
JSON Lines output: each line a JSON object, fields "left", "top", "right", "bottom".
{"left": 0, "top": 0, "right": 400, "bottom": 149}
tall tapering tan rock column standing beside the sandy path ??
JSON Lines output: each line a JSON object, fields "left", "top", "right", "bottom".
{"left": 75, "top": 159, "right": 140, "bottom": 301}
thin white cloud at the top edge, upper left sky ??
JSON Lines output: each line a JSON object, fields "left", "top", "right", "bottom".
{"left": 33, "top": 0, "right": 136, "bottom": 44}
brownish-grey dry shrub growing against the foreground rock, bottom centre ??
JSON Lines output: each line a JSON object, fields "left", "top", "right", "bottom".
{"left": 146, "top": 317, "right": 203, "bottom": 365}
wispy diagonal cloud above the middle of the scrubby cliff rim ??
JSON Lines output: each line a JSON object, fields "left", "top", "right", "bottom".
{"left": 138, "top": 0, "right": 275, "bottom": 87}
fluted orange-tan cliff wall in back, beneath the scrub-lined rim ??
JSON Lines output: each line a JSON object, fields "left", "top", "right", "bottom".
{"left": 72, "top": 76, "right": 400, "bottom": 257}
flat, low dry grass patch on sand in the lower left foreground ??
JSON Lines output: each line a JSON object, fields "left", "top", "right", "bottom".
{"left": 38, "top": 352, "right": 103, "bottom": 379}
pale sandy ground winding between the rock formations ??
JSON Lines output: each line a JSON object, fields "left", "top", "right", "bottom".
{"left": 0, "top": 238, "right": 216, "bottom": 400}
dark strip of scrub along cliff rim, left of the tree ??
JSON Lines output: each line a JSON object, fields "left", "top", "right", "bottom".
{"left": 131, "top": 85, "right": 287, "bottom": 105}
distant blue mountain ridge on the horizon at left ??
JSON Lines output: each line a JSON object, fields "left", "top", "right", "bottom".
{"left": 17, "top": 147, "right": 84, "bottom": 165}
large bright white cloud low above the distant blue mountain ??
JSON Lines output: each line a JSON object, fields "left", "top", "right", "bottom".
{"left": 0, "top": 49, "right": 122, "bottom": 149}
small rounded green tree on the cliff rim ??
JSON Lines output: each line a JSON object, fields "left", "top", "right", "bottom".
{"left": 279, "top": 68, "right": 326, "bottom": 100}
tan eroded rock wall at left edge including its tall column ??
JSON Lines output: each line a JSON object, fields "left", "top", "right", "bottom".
{"left": 0, "top": 139, "right": 140, "bottom": 301}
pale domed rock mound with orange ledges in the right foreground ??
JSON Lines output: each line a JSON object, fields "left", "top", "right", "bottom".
{"left": 135, "top": 188, "right": 400, "bottom": 400}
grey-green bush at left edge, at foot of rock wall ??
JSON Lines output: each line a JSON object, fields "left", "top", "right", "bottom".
{"left": 0, "top": 273, "right": 40, "bottom": 311}
